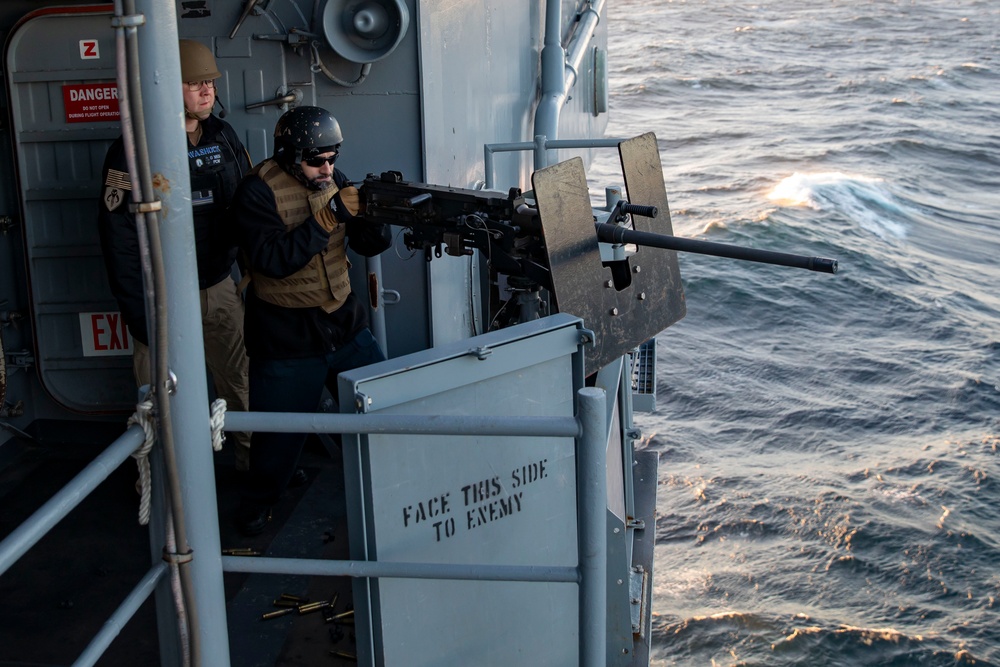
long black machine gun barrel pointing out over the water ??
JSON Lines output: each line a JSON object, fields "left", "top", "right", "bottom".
{"left": 596, "top": 223, "right": 837, "bottom": 273}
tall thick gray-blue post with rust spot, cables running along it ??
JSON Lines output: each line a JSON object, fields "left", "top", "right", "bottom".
{"left": 135, "top": 0, "right": 230, "bottom": 667}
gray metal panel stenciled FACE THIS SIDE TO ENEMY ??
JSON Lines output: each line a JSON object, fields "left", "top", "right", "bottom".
{"left": 340, "top": 315, "right": 582, "bottom": 667}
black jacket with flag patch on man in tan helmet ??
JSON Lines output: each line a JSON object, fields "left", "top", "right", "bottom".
{"left": 97, "top": 116, "right": 251, "bottom": 345}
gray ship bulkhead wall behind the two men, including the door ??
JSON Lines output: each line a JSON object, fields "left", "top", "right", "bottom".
{"left": 0, "top": 0, "right": 607, "bottom": 438}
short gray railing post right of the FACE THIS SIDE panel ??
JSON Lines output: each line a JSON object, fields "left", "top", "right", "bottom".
{"left": 577, "top": 387, "right": 608, "bottom": 667}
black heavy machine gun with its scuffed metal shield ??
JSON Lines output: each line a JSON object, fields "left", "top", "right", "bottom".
{"left": 359, "top": 134, "right": 837, "bottom": 372}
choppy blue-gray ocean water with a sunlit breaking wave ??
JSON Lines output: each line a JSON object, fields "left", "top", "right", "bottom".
{"left": 589, "top": 0, "right": 1000, "bottom": 666}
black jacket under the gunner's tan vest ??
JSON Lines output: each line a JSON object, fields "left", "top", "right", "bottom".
{"left": 232, "top": 162, "right": 392, "bottom": 359}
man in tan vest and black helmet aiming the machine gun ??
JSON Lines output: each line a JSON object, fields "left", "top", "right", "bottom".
{"left": 233, "top": 106, "right": 391, "bottom": 535}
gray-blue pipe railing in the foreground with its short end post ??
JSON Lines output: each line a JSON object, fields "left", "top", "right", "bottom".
{"left": 0, "top": 387, "right": 608, "bottom": 667}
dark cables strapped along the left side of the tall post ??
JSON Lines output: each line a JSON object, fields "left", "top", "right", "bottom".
{"left": 115, "top": 0, "right": 200, "bottom": 665}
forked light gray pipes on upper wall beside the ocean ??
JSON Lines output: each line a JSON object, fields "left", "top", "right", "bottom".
{"left": 534, "top": 0, "right": 606, "bottom": 164}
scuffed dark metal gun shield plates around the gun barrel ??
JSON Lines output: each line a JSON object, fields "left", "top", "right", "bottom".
{"left": 532, "top": 133, "right": 686, "bottom": 375}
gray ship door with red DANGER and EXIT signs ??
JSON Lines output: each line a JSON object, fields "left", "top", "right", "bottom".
{"left": 4, "top": 5, "right": 136, "bottom": 413}
